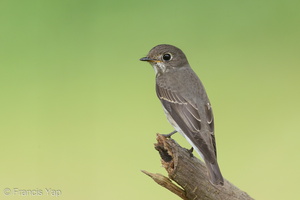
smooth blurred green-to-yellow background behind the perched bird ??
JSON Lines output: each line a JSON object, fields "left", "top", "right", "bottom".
{"left": 0, "top": 0, "right": 300, "bottom": 200}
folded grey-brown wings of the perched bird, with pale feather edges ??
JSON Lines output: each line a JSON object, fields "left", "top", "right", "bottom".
{"left": 156, "top": 85, "right": 216, "bottom": 163}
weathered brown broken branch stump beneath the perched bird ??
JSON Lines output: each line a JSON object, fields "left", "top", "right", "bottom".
{"left": 143, "top": 134, "right": 253, "bottom": 200}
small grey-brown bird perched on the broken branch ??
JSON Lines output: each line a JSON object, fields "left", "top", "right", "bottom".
{"left": 140, "top": 44, "right": 224, "bottom": 185}
